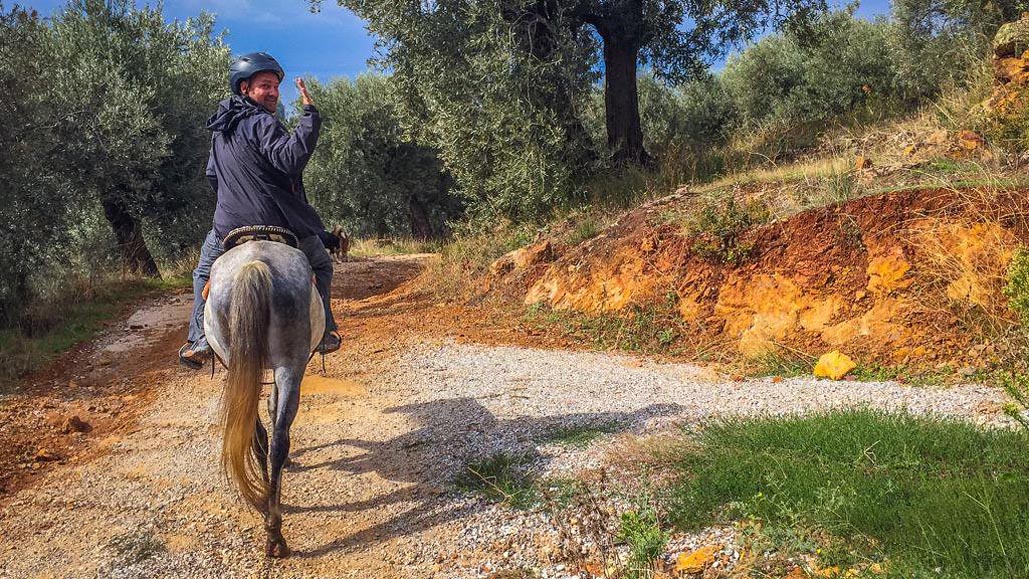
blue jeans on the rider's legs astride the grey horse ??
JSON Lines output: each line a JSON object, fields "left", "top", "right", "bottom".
{"left": 189, "top": 229, "right": 336, "bottom": 343}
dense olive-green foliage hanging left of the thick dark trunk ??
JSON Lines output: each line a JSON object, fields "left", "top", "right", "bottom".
{"left": 343, "top": 2, "right": 595, "bottom": 221}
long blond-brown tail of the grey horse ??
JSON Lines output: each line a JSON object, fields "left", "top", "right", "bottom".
{"left": 221, "top": 261, "right": 272, "bottom": 512}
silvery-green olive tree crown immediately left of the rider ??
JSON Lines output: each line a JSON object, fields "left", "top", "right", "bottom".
{"left": 47, "top": 0, "right": 229, "bottom": 254}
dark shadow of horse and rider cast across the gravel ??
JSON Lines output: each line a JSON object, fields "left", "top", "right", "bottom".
{"left": 283, "top": 398, "right": 682, "bottom": 557}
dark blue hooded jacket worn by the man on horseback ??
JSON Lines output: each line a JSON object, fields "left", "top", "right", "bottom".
{"left": 207, "top": 97, "right": 325, "bottom": 239}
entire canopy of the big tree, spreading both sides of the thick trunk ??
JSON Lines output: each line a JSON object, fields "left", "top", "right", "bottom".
{"left": 329, "top": 0, "right": 824, "bottom": 214}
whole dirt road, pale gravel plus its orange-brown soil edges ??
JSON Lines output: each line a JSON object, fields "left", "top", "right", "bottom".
{"left": 0, "top": 256, "right": 1001, "bottom": 579}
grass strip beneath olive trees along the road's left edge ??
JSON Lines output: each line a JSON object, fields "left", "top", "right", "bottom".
{"left": 0, "top": 276, "right": 192, "bottom": 386}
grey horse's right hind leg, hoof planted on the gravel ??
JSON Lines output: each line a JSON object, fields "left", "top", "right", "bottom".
{"left": 264, "top": 365, "right": 305, "bottom": 557}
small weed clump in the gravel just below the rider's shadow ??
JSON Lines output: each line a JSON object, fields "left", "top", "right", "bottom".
{"left": 454, "top": 453, "right": 538, "bottom": 508}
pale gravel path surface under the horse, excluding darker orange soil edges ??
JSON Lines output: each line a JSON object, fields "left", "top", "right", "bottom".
{"left": 0, "top": 342, "right": 1003, "bottom": 579}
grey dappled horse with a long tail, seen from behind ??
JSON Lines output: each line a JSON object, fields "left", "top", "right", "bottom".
{"left": 204, "top": 241, "right": 325, "bottom": 557}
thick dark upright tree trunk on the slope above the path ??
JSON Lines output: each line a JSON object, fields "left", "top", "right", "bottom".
{"left": 601, "top": 32, "right": 651, "bottom": 165}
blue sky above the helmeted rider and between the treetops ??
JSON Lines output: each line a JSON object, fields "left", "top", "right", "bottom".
{"left": 19, "top": 0, "right": 889, "bottom": 103}
